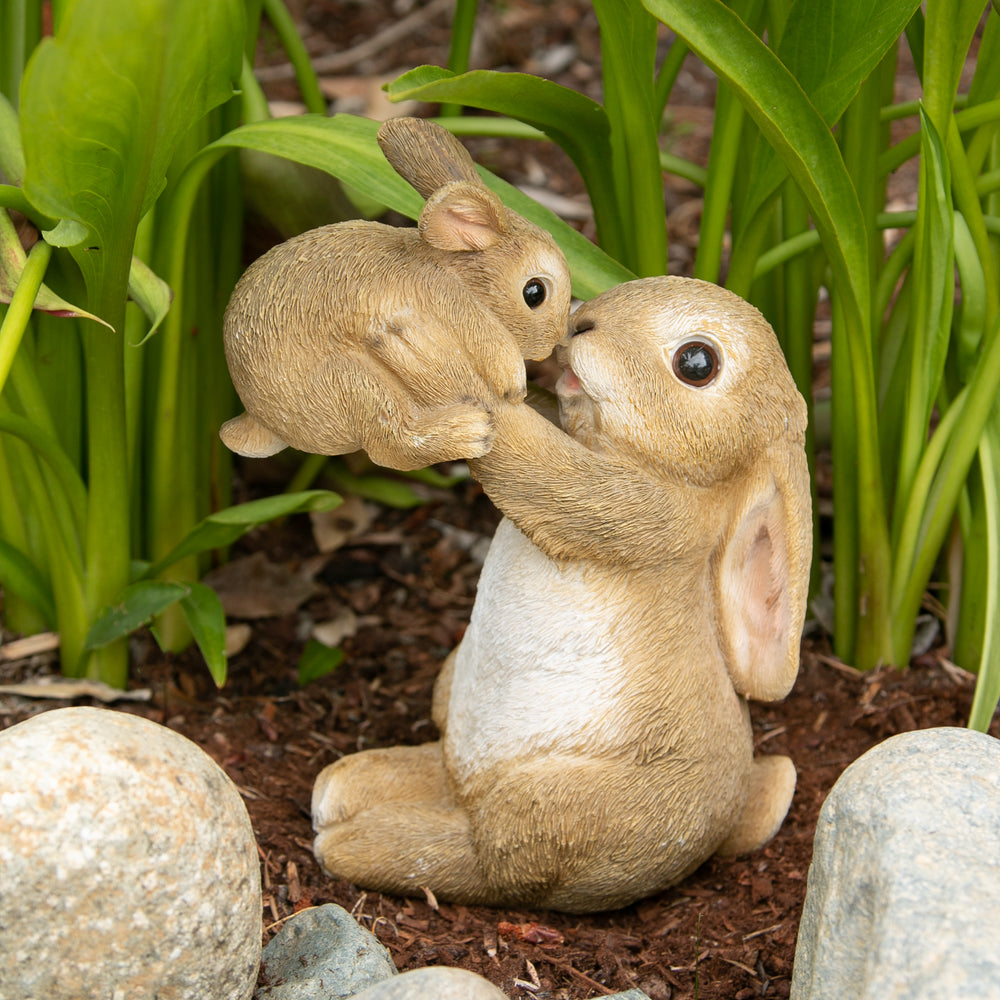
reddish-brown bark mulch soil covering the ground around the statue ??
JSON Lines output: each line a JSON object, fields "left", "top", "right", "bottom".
{"left": 0, "top": 0, "right": 1000, "bottom": 1000}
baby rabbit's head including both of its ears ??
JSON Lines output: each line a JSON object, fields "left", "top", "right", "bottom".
{"left": 378, "top": 118, "right": 571, "bottom": 360}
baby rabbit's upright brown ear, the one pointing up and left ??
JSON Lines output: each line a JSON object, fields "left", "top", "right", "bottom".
{"left": 378, "top": 118, "right": 482, "bottom": 198}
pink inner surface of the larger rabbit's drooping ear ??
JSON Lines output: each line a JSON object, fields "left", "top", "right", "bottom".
{"left": 718, "top": 480, "right": 802, "bottom": 701}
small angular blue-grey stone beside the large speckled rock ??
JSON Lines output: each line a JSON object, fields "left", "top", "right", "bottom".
{"left": 255, "top": 903, "right": 396, "bottom": 1000}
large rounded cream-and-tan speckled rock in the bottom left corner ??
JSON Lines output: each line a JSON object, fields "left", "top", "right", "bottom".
{"left": 0, "top": 708, "right": 261, "bottom": 1000}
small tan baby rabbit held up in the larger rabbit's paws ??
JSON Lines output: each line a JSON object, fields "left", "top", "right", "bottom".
{"left": 220, "top": 118, "right": 570, "bottom": 469}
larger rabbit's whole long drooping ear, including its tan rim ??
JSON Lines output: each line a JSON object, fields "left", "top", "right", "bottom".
{"left": 716, "top": 442, "right": 812, "bottom": 701}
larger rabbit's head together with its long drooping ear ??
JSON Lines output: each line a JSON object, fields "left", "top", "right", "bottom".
{"left": 557, "top": 278, "right": 812, "bottom": 700}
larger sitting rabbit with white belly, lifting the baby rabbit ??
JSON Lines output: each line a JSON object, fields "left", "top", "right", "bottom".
{"left": 312, "top": 278, "right": 811, "bottom": 912}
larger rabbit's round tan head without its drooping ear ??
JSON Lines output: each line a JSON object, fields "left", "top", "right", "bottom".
{"left": 558, "top": 278, "right": 806, "bottom": 486}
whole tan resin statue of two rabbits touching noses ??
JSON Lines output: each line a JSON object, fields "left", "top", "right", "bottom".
{"left": 223, "top": 119, "right": 811, "bottom": 912}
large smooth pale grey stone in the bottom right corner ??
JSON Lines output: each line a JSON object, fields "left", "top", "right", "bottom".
{"left": 791, "top": 729, "right": 1000, "bottom": 1000}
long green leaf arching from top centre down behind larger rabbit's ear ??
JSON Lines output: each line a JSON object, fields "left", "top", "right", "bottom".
{"left": 644, "top": 0, "right": 892, "bottom": 667}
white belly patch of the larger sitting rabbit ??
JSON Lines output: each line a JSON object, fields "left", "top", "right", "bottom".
{"left": 445, "top": 518, "right": 623, "bottom": 782}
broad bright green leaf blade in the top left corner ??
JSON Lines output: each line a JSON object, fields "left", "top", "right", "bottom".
{"left": 20, "top": 0, "right": 244, "bottom": 295}
